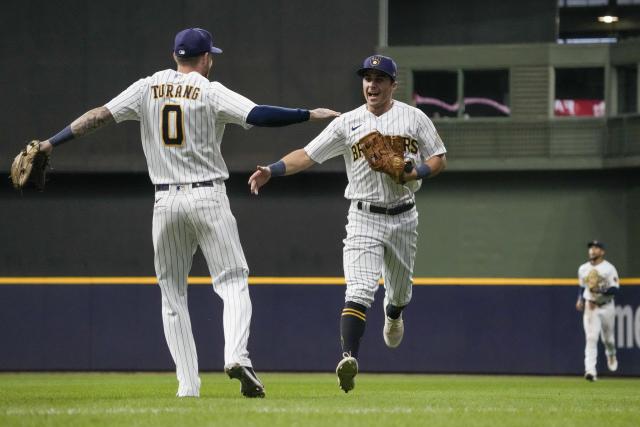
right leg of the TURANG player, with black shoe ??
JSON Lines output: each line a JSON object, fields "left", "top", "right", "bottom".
{"left": 192, "top": 186, "right": 264, "bottom": 397}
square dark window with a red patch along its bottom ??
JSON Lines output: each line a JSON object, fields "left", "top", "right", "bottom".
{"left": 554, "top": 67, "right": 605, "bottom": 117}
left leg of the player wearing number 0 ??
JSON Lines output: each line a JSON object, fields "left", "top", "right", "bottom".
{"left": 152, "top": 191, "right": 200, "bottom": 397}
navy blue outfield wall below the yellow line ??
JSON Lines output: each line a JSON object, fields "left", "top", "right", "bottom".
{"left": 0, "top": 284, "right": 640, "bottom": 375}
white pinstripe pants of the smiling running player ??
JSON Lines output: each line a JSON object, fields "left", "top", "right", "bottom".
{"left": 343, "top": 201, "right": 418, "bottom": 307}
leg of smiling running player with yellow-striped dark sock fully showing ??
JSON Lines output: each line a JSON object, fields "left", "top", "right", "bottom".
{"left": 336, "top": 208, "right": 384, "bottom": 392}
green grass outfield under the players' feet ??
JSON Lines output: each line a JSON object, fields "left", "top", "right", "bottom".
{"left": 0, "top": 373, "right": 640, "bottom": 427}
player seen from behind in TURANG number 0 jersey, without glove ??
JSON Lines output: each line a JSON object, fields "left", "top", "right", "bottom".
{"left": 32, "top": 28, "right": 338, "bottom": 397}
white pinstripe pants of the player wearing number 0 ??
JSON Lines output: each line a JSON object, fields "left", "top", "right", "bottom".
{"left": 152, "top": 183, "right": 251, "bottom": 396}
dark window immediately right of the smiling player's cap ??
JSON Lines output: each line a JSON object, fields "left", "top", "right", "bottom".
{"left": 413, "top": 71, "right": 458, "bottom": 118}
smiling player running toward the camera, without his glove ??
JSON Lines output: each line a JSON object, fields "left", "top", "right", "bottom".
{"left": 249, "top": 55, "right": 446, "bottom": 392}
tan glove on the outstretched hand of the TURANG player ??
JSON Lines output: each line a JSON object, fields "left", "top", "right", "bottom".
{"left": 11, "top": 140, "right": 49, "bottom": 191}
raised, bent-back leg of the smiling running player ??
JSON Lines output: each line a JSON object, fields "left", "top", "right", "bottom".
{"left": 382, "top": 209, "right": 418, "bottom": 348}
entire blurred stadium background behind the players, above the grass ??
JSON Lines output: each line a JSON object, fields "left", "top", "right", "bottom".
{"left": 0, "top": 0, "right": 640, "bottom": 376}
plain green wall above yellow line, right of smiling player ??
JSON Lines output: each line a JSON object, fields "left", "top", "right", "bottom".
{"left": 416, "top": 170, "right": 640, "bottom": 277}
